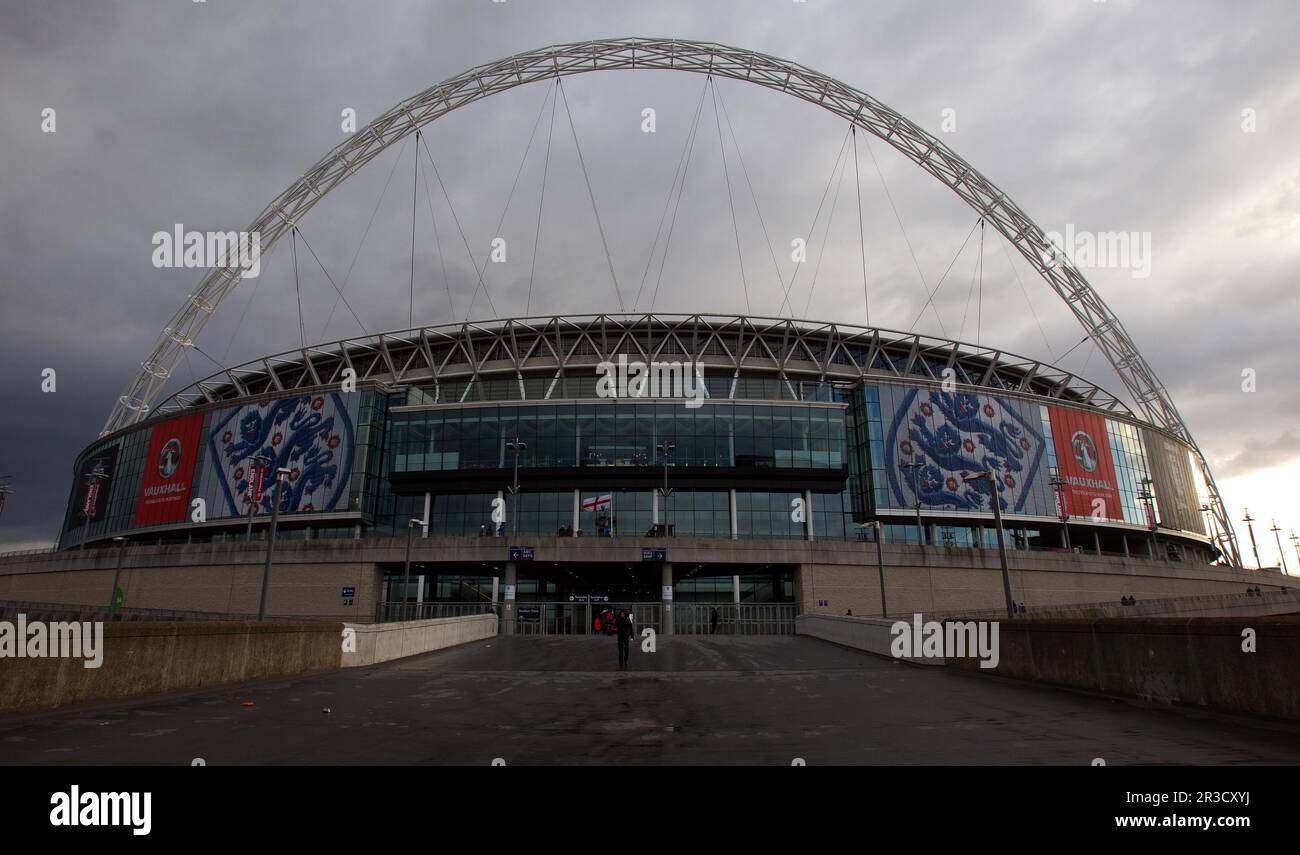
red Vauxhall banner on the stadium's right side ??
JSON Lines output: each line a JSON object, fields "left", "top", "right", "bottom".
{"left": 1048, "top": 407, "right": 1123, "bottom": 520}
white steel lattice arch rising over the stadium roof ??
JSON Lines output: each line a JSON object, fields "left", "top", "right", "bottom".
{"left": 104, "top": 38, "right": 1240, "bottom": 567}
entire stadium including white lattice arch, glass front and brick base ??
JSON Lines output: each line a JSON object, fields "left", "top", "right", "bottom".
{"left": 0, "top": 39, "right": 1290, "bottom": 633}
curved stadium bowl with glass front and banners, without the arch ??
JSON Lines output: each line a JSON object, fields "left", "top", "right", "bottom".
{"left": 45, "top": 314, "right": 1218, "bottom": 613}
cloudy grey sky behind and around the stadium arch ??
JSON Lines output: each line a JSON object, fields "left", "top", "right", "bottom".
{"left": 0, "top": 0, "right": 1300, "bottom": 565}
